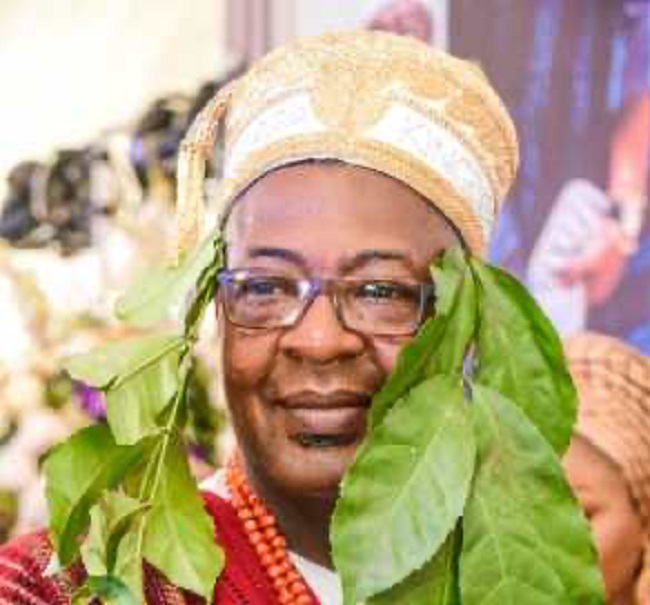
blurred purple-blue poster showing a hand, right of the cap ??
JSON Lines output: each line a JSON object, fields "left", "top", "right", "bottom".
{"left": 449, "top": 0, "right": 650, "bottom": 354}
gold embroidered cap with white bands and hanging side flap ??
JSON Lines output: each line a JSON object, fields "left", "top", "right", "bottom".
{"left": 177, "top": 31, "right": 518, "bottom": 254}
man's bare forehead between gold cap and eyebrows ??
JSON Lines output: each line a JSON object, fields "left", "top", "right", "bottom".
{"left": 228, "top": 162, "right": 451, "bottom": 246}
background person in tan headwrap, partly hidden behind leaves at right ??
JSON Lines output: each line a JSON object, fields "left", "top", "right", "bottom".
{"left": 565, "top": 333, "right": 650, "bottom": 605}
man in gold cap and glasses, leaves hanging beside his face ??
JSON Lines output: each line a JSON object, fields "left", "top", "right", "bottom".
{"left": 0, "top": 32, "right": 602, "bottom": 605}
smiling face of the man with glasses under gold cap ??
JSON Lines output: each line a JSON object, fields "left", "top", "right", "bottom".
{"left": 218, "top": 164, "right": 457, "bottom": 498}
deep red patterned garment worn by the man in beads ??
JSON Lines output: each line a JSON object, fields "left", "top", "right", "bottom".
{"left": 0, "top": 494, "right": 318, "bottom": 605}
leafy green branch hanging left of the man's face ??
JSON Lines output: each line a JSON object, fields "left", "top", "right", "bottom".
{"left": 45, "top": 231, "right": 223, "bottom": 604}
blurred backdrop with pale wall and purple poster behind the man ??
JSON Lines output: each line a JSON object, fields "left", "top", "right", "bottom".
{"left": 0, "top": 0, "right": 650, "bottom": 540}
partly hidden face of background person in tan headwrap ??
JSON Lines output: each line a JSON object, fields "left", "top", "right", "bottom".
{"left": 564, "top": 437, "right": 643, "bottom": 604}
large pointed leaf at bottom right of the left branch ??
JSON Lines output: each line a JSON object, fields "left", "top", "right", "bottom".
{"left": 143, "top": 436, "right": 223, "bottom": 601}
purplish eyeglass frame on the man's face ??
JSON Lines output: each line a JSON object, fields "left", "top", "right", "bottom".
{"left": 215, "top": 268, "right": 435, "bottom": 337}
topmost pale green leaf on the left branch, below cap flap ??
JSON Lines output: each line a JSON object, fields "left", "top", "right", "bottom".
{"left": 116, "top": 235, "right": 221, "bottom": 327}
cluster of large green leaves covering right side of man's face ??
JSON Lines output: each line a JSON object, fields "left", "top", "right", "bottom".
{"left": 331, "top": 249, "right": 604, "bottom": 605}
